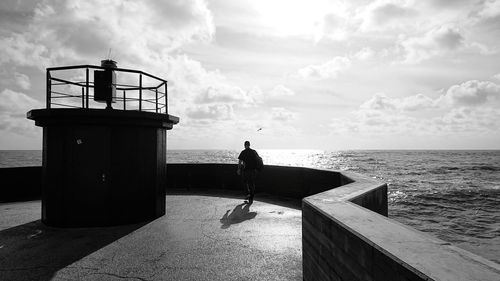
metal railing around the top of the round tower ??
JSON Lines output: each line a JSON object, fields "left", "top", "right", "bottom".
{"left": 46, "top": 65, "right": 168, "bottom": 114}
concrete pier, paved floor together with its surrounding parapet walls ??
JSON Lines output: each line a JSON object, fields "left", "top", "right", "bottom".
{"left": 0, "top": 164, "right": 500, "bottom": 281}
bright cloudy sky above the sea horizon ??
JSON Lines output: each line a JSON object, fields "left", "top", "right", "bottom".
{"left": 0, "top": 0, "right": 500, "bottom": 150}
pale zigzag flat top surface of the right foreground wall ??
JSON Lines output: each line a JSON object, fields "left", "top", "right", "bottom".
{"left": 303, "top": 171, "right": 500, "bottom": 281}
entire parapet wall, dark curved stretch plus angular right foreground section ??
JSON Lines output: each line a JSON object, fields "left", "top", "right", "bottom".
{"left": 0, "top": 164, "right": 500, "bottom": 281}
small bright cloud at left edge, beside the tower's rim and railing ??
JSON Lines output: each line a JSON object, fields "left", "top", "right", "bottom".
{"left": 0, "top": 89, "right": 43, "bottom": 136}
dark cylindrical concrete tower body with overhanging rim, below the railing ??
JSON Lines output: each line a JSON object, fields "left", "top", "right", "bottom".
{"left": 28, "top": 108, "right": 179, "bottom": 227}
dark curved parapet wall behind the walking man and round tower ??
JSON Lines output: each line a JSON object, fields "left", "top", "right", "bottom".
{"left": 0, "top": 164, "right": 342, "bottom": 202}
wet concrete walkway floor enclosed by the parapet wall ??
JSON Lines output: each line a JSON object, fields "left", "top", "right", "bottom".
{"left": 0, "top": 191, "right": 302, "bottom": 280}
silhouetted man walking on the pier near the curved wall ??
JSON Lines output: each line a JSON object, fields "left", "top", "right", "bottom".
{"left": 238, "top": 141, "right": 258, "bottom": 204}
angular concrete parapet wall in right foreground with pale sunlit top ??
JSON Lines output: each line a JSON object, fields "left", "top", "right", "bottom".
{"left": 302, "top": 172, "right": 500, "bottom": 281}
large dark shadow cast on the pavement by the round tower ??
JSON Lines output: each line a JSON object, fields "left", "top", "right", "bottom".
{"left": 0, "top": 220, "right": 146, "bottom": 280}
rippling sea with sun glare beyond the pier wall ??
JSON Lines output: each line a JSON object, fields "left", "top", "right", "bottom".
{"left": 0, "top": 149, "right": 500, "bottom": 263}
